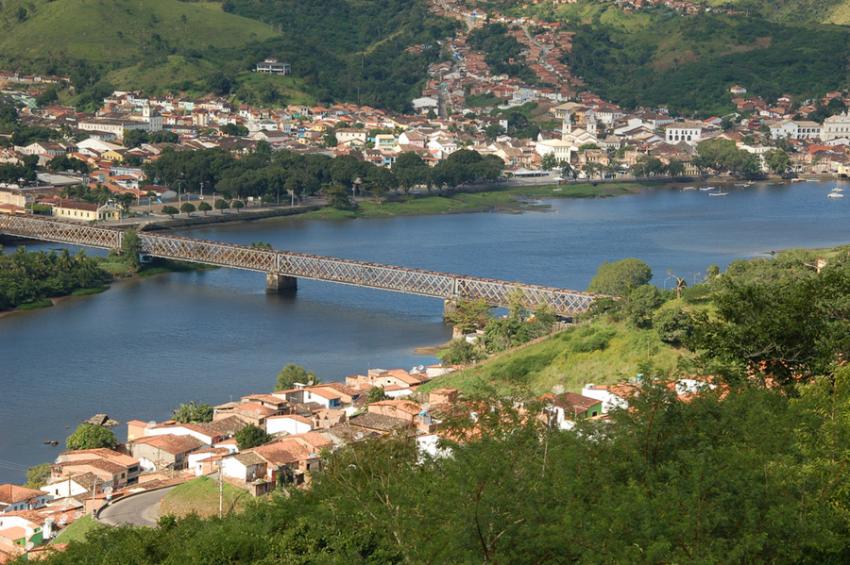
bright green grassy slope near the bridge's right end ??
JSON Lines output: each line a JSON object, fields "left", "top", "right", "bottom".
{"left": 425, "top": 320, "right": 687, "bottom": 394}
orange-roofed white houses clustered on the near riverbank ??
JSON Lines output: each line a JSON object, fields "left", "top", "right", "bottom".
{"left": 0, "top": 352, "right": 716, "bottom": 563}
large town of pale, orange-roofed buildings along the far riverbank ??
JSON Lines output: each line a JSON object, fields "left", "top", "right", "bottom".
{"left": 0, "top": 4, "right": 850, "bottom": 222}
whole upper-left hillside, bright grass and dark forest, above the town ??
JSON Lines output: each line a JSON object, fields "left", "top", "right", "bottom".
{"left": 0, "top": 0, "right": 454, "bottom": 110}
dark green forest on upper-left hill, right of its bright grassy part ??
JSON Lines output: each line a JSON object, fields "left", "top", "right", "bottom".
{"left": 226, "top": 0, "right": 455, "bottom": 110}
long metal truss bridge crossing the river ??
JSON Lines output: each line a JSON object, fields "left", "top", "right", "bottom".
{"left": 0, "top": 215, "right": 595, "bottom": 317}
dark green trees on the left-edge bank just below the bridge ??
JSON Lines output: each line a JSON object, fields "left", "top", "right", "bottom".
{"left": 0, "top": 247, "right": 112, "bottom": 311}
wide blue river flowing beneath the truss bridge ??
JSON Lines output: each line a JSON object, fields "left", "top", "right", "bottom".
{"left": 0, "top": 182, "right": 850, "bottom": 482}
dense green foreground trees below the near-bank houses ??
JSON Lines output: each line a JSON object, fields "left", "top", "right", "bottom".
{"left": 38, "top": 368, "right": 850, "bottom": 565}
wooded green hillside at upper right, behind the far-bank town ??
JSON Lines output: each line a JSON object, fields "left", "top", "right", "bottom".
{"left": 558, "top": 4, "right": 850, "bottom": 115}
